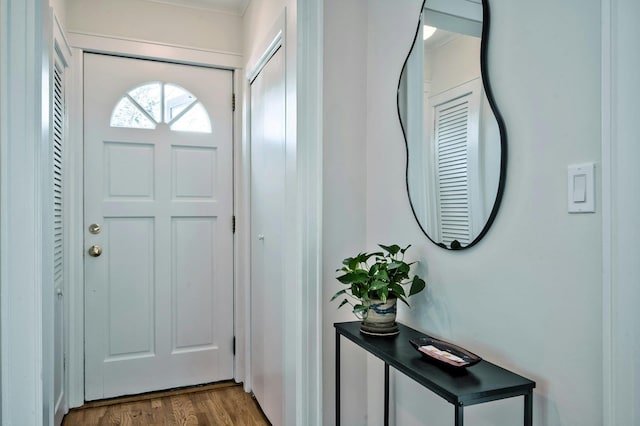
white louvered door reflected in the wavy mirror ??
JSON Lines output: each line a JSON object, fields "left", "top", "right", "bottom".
{"left": 432, "top": 80, "right": 481, "bottom": 247}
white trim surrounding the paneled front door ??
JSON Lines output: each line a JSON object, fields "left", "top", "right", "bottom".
{"left": 66, "top": 33, "right": 245, "bottom": 408}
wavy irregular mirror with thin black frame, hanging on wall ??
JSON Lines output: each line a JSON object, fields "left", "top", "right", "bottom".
{"left": 398, "top": 0, "right": 507, "bottom": 250}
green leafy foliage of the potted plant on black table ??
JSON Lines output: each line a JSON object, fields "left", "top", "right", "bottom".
{"left": 331, "top": 244, "right": 426, "bottom": 319}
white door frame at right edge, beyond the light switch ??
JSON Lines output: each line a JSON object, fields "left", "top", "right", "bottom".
{"left": 601, "top": 0, "right": 640, "bottom": 426}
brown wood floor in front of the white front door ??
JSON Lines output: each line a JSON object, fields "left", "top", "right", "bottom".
{"left": 62, "top": 383, "right": 270, "bottom": 426}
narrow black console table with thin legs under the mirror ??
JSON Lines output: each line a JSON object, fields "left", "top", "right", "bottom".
{"left": 334, "top": 321, "right": 536, "bottom": 426}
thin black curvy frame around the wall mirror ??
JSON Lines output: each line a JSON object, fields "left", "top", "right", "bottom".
{"left": 396, "top": 0, "right": 508, "bottom": 250}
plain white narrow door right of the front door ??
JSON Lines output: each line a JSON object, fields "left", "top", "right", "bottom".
{"left": 250, "top": 48, "right": 285, "bottom": 425}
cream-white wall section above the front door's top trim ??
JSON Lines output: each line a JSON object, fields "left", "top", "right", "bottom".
{"left": 65, "top": 0, "right": 243, "bottom": 53}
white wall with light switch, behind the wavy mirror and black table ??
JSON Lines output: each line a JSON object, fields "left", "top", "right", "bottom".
{"left": 324, "top": 0, "right": 602, "bottom": 426}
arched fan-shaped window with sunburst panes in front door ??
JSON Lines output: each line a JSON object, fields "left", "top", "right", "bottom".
{"left": 110, "top": 82, "right": 211, "bottom": 133}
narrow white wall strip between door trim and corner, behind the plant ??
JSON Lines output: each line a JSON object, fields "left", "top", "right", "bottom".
{"left": 322, "top": 0, "right": 368, "bottom": 426}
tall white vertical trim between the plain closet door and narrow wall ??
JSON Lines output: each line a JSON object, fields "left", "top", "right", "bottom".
{"left": 294, "top": 0, "right": 324, "bottom": 426}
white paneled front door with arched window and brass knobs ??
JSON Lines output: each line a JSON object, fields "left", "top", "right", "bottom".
{"left": 84, "top": 54, "right": 233, "bottom": 400}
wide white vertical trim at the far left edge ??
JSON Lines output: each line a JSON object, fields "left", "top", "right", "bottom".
{"left": 0, "top": 0, "right": 53, "bottom": 424}
